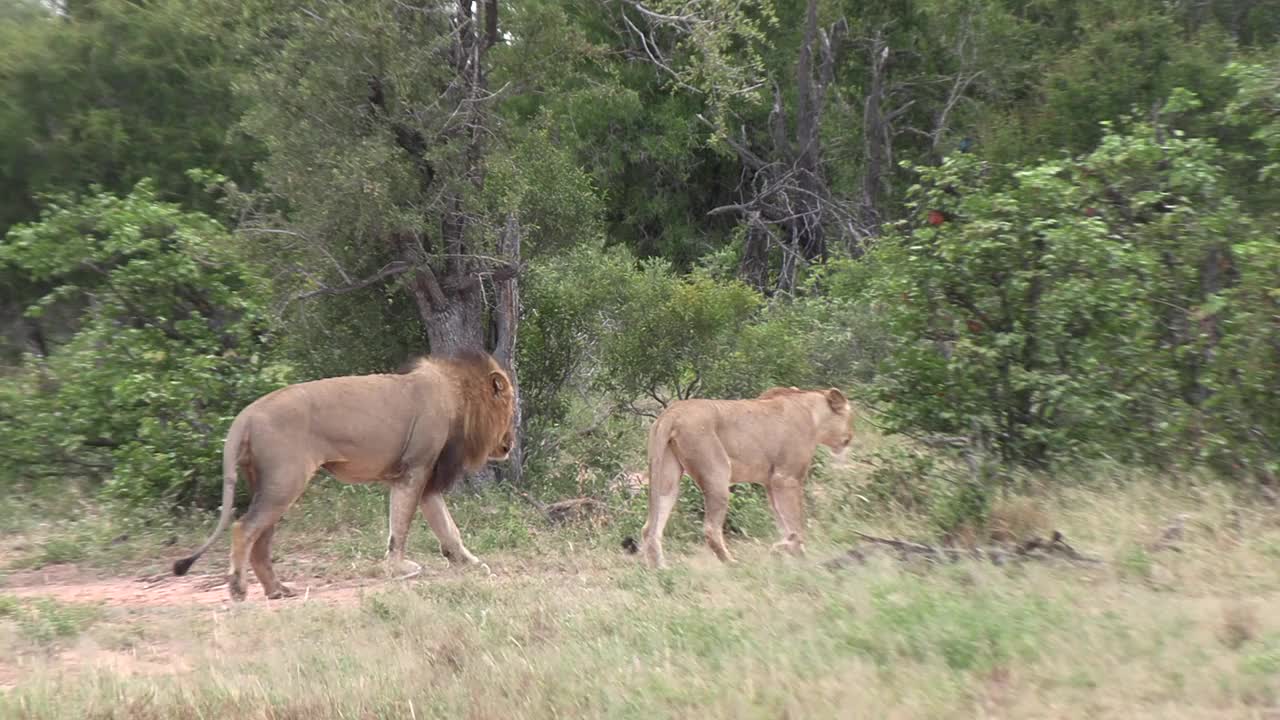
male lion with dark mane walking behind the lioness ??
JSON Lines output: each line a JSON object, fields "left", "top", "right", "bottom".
{"left": 173, "top": 352, "right": 515, "bottom": 601}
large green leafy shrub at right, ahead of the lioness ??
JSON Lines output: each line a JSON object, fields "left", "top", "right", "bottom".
{"left": 855, "top": 99, "right": 1280, "bottom": 473}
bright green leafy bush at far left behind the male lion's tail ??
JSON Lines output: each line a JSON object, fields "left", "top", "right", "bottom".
{"left": 0, "top": 183, "right": 288, "bottom": 503}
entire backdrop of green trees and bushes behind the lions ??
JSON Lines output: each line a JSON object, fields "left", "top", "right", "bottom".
{"left": 0, "top": 0, "right": 1280, "bottom": 504}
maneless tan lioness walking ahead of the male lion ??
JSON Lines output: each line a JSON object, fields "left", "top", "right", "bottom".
{"left": 625, "top": 387, "right": 852, "bottom": 568}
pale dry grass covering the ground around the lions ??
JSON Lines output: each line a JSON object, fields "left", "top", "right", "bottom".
{"left": 0, "top": 461, "right": 1280, "bottom": 719}
